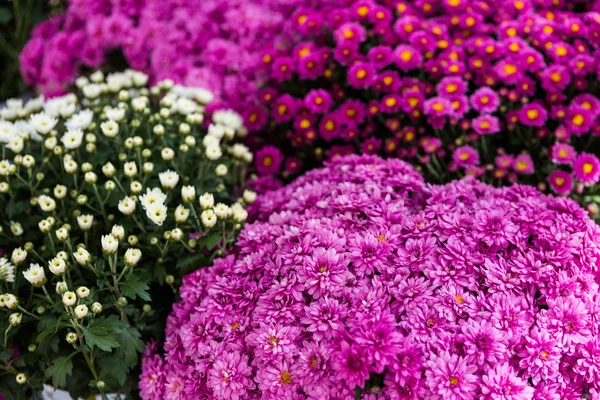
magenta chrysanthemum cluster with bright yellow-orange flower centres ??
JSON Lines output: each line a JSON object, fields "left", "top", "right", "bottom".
{"left": 244, "top": 0, "right": 600, "bottom": 219}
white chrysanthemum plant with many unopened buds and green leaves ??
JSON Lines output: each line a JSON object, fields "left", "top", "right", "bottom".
{"left": 0, "top": 71, "right": 254, "bottom": 398}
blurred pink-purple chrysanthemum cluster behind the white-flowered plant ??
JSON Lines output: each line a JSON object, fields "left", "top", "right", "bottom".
{"left": 20, "top": 0, "right": 342, "bottom": 106}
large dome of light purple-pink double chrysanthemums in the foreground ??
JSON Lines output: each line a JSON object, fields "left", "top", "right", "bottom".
{"left": 140, "top": 155, "right": 600, "bottom": 400}
